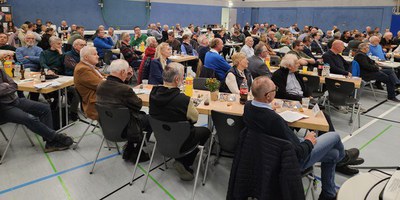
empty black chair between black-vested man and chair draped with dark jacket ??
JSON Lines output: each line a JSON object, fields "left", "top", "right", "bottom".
{"left": 203, "top": 110, "right": 245, "bottom": 185}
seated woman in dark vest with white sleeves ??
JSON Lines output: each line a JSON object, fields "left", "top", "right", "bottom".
{"left": 221, "top": 52, "right": 253, "bottom": 94}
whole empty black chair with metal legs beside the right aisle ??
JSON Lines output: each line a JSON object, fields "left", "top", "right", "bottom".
{"left": 325, "top": 78, "right": 361, "bottom": 135}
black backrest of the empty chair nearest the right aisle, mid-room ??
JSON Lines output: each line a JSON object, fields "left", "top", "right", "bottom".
{"left": 325, "top": 78, "right": 355, "bottom": 106}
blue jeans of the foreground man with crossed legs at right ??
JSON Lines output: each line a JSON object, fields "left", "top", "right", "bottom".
{"left": 300, "top": 132, "right": 345, "bottom": 197}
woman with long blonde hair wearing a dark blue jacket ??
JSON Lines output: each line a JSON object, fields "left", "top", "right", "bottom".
{"left": 149, "top": 42, "right": 172, "bottom": 85}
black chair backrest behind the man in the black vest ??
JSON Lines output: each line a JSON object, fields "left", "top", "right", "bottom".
{"left": 149, "top": 117, "right": 196, "bottom": 158}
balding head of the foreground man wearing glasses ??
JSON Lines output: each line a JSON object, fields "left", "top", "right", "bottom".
{"left": 251, "top": 76, "right": 276, "bottom": 102}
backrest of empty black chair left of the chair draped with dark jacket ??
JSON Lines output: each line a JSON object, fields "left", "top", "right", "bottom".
{"left": 211, "top": 110, "right": 245, "bottom": 153}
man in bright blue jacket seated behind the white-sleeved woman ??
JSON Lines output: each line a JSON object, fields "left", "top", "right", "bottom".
{"left": 204, "top": 38, "right": 231, "bottom": 82}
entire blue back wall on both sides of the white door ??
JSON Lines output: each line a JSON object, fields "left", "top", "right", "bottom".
{"left": 8, "top": 0, "right": 392, "bottom": 30}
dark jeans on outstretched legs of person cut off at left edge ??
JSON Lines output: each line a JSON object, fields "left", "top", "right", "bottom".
{"left": 0, "top": 98, "right": 56, "bottom": 141}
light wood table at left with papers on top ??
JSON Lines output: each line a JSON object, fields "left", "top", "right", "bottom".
{"left": 14, "top": 72, "right": 74, "bottom": 130}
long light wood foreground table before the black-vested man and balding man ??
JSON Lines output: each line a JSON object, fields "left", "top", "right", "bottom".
{"left": 135, "top": 85, "right": 329, "bottom": 131}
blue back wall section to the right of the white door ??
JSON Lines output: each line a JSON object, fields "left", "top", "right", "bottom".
{"left": 245, "top": 7, "right": 392, "bottom": 30}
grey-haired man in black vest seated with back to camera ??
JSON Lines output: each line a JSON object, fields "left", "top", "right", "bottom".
{"left": 149, "top": 63, "right": 210, "bottom": 181}
